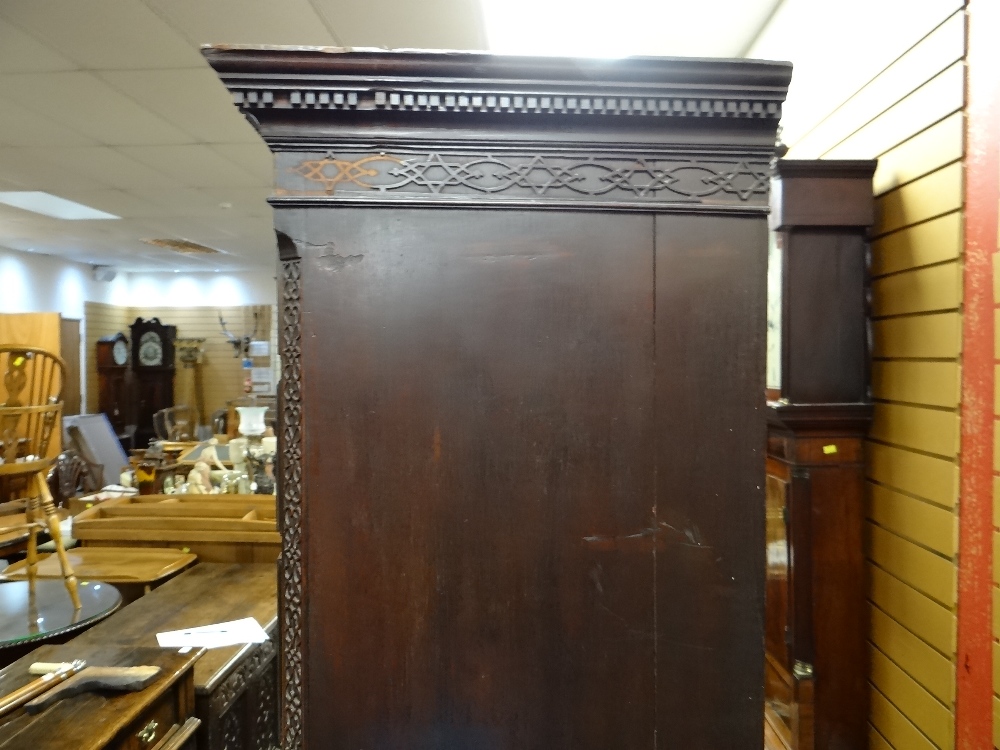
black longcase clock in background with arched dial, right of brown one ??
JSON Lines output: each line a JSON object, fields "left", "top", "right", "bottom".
{"left": 130, "top": 318, "right": 177, "bottom": 447}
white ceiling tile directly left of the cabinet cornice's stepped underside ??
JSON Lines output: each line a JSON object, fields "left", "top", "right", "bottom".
{"left": 98, "top": 66, "right": 266, "bottom": 149}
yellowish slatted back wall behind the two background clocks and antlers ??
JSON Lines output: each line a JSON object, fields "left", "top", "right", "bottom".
{"left": 84, "top": 302, "right": 277, "bottom": 428}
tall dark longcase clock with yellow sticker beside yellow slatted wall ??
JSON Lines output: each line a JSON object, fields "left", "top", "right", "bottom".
{"left": 764, "top": 160, "right": 876, "bottom": 750}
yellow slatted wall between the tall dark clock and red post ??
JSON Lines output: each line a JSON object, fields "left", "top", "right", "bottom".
{"left": 789, "top": 11, "right": 964, "bottom": 750}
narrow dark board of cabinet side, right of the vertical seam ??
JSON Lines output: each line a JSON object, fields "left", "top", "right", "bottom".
{"left": 652, "top": 214, "right": 767, "bottom": 750}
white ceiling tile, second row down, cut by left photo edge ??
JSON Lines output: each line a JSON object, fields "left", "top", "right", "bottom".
{"left": 0, "top": 72, "right": 191, "bottom": 145}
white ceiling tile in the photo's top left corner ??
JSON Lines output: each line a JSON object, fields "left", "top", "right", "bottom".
{"left": 0, "top": 0, "right": 203, "bottom": 69}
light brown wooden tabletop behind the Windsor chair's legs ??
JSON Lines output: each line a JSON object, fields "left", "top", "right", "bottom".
{"left": 0, "top": 547, "right": 198, "bottom": 604}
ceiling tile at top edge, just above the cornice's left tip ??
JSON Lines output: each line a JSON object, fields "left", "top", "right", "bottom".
{"left": 145, "top": 0, "right": 337, "bottom": 46}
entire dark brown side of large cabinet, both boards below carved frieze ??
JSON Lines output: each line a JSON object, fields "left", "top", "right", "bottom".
{"left": 280, "top": 208, "right": 765, "bottom": 750}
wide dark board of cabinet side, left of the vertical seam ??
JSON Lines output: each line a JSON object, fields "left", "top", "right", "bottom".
{"left": 296, "top": 208, "right": 656, "bottom": 750}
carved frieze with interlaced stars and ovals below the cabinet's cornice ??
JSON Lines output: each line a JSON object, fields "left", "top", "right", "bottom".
{"left": 274, "top": 149, "right": 770, "bottom": 210}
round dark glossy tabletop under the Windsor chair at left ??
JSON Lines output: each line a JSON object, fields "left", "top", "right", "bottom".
{"left": 0, "top": 577, "right": 122, "bottom": 667}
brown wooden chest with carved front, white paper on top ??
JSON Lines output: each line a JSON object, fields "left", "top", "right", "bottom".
{"left": 75, "top": 563, "right": 278, "bottom": 750}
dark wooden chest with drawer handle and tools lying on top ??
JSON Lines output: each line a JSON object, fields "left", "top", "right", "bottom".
{"left": 0, "top": 641, "right": 205, "bottom": 750}
